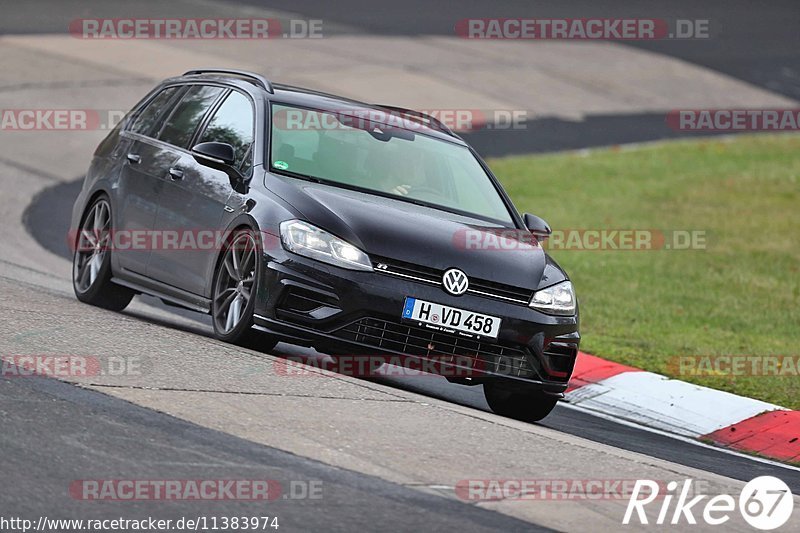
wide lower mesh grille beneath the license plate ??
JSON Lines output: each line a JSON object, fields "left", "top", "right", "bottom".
{"left": 334, "top": 318, "right": 536, "bottom": 378}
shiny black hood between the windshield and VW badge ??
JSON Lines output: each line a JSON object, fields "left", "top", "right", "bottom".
{"left": 269, "top": 176, "right": 564, "bottom": 290}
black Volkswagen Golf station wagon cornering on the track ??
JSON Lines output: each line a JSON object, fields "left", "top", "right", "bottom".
{"left": 70, "top": 69, "right": 580, "bottom": 421}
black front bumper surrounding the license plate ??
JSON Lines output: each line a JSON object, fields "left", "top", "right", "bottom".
{"left": 255, "top": 250, "right": 580, "bottom": 394}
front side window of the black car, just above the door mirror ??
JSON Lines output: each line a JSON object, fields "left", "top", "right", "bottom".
{"left": 199, "top": 91, "right": 255, "bottom": 174}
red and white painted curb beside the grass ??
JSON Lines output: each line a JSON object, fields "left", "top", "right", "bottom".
{"left": 566, "top": 353, "right": 800, "bottom": 462}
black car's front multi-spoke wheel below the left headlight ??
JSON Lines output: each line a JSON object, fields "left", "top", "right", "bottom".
{"left": 211, "top": 229, "right": 278, "bottom": 351}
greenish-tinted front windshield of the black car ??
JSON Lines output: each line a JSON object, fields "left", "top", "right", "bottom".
{"left": 270, "top": 104, "right": 513, "bottom": 225}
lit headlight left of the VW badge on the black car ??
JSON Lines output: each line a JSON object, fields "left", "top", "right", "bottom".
{"left": 281, "top": 220, "right": 372, "bottom": 270}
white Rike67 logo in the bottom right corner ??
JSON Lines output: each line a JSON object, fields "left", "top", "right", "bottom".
{"left": 622, "top": 476, "right": 794, "bottom": 531}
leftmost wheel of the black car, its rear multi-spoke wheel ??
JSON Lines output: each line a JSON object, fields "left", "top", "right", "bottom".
{"left": 72, "top": 195, "right": 135, "bottom": 311}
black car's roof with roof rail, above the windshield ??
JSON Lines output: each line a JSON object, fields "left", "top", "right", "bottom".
{"left": 165, "top": 69, "right": 467, "bottom": 146}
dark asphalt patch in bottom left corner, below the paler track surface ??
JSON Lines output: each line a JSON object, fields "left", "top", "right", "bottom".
{"left": 0, "top": 372, "right": 547, "bottom": 531}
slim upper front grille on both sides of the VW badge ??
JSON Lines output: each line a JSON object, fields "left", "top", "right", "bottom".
{"left": 373, "top": 258, "right": 533, "bottom": 305}
